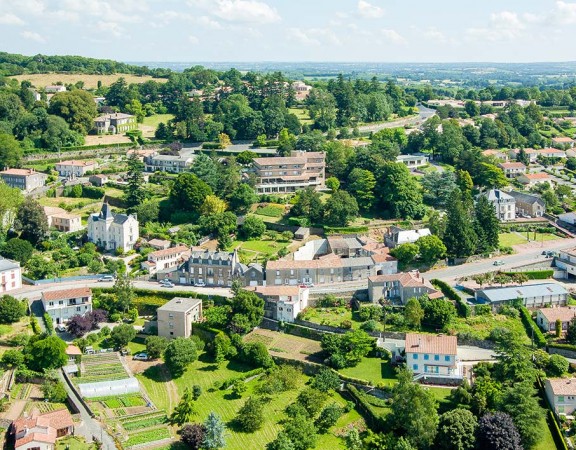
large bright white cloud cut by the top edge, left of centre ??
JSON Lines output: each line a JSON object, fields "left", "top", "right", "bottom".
{"left": 188, "top": 0, "right": 280, "bottom": 24}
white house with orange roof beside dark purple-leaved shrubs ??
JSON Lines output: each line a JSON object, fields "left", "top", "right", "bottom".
{"left": 42, "top": 288, "right": 92, "bottom": 324}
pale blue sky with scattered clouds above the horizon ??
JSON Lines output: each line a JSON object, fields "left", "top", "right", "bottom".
{"left": 0, "top": 0, "right": 576, "bottom": 62}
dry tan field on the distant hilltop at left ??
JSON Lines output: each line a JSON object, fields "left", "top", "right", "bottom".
{"left": 11, "top": 73, "right": 168, "bottom": 89}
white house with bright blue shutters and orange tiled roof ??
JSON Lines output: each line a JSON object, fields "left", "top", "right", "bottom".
{"left": 405, "top": 333, "right": 462, "bottom": 378}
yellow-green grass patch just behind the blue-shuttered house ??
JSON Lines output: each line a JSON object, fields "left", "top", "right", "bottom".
{"left": 446, "top": 314, "right": 529, "bottom": 343}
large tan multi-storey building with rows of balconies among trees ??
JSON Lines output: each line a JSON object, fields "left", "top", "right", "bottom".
{"left": 254, "top": 151, "right": 326, "bottom": 194}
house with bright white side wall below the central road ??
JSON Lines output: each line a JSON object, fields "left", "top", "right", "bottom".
{"left": 254, "top": 286, "right": 310, "bottom": 322}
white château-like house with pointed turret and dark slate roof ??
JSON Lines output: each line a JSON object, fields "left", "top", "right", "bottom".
{"left": 88, "top": 203, "right": 139, "bottom": 252}
